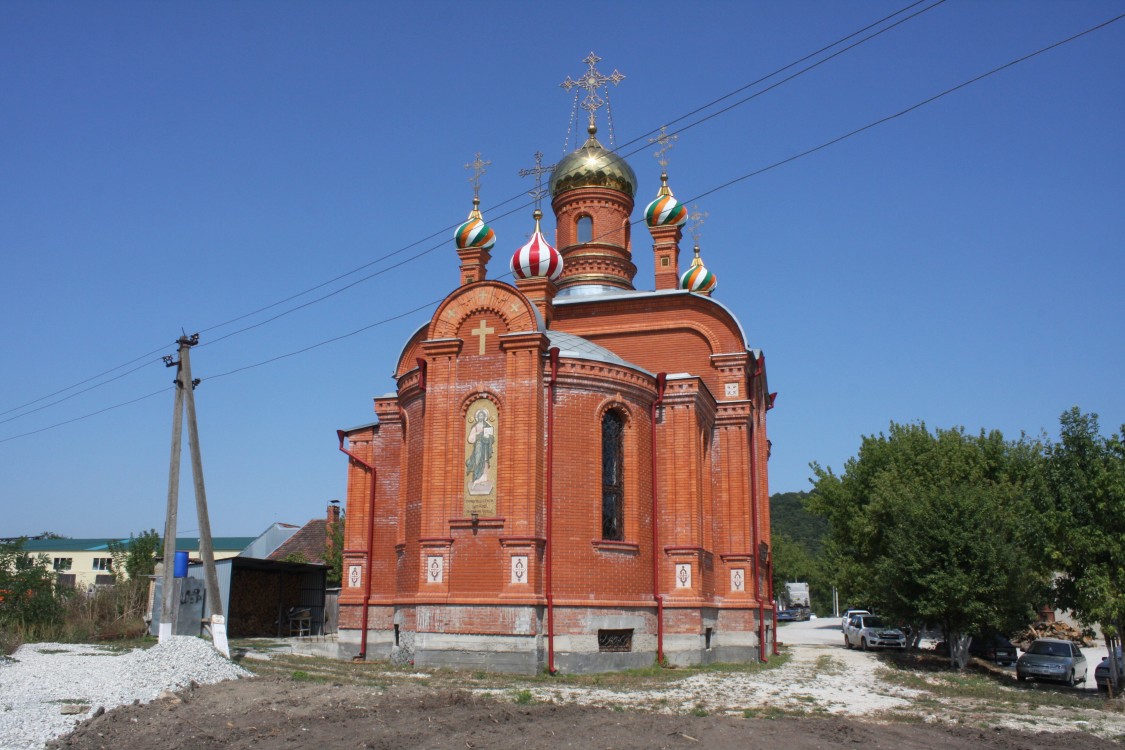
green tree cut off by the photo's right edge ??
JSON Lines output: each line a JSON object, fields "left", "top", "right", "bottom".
{"left": 1046, "top": 407, "right": 1125, "bottom": 692}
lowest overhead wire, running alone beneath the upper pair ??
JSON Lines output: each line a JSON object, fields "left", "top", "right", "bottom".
{"left": 0, "top": 8, "right": 1125, "bottom": 443}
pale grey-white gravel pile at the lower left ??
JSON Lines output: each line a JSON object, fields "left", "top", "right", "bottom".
{"left": 0, "top": 635, "right": 250, "bottom": 750}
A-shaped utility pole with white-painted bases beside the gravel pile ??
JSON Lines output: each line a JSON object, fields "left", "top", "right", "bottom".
{"left": 160, "top": 334, "right": 231, "bottom": 657}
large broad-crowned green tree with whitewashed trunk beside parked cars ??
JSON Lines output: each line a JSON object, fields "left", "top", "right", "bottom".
{"left": 808, "top": 423, "right": 1047, "bottom": 668}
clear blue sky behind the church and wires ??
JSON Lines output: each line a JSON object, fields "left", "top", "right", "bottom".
{"left": 0, "top": 0, "right": 1125, "bottom": 536}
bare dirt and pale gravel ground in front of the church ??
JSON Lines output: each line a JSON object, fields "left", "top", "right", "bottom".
{"left": 51, "top": 621, "right": 1125, "bottom": 750}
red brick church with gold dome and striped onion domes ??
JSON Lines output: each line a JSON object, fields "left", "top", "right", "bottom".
{"left": 339, "top": 56, "right": 774, "bottom": 674}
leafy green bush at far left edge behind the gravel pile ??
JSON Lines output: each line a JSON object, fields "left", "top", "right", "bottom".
{"left": 0, "top": 540, "right": 65, "bottom": 629}
